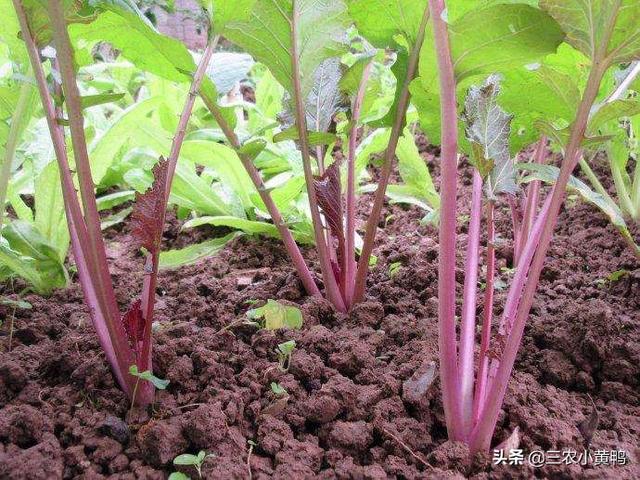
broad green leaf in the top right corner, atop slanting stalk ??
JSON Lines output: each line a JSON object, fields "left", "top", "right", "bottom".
{"left": 540, "top": 0, "right": 640, "bottom": 63}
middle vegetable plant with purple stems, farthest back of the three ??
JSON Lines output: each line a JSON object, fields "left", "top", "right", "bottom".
{"left": 205, "top": 0, "right": 429, "bottom": 311}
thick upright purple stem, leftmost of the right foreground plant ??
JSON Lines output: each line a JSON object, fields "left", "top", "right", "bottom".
{"left": 429, "top": 0, "right": 465, "bottom": 440}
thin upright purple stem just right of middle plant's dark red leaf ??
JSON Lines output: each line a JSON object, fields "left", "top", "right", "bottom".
{"left": 345, "top": 62, "right": 372, "bottom": 308}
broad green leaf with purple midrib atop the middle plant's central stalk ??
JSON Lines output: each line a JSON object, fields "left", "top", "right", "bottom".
{"left": 214, "top": 0, "right": 349, "bottom": 98}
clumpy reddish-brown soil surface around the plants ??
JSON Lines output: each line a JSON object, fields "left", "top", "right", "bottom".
{"left": 0, "top": 152, "right": 640, "bottom": 480}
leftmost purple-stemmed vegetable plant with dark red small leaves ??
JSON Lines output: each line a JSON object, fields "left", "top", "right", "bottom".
{"left": 8, "top": 0, "right": 216, "bottom": 406}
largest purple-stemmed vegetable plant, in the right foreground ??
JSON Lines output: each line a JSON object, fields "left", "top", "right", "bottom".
{"left": 429, "top": 0, "right": 640, "bottom": 452}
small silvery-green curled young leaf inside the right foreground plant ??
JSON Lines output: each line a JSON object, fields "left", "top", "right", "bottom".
{"left": 464, "top": 75, "right": 517, "bottom": 199}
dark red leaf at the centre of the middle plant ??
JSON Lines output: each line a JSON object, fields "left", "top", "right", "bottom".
{"left": 313, "top": 162, "right": 344, "bottom": 272}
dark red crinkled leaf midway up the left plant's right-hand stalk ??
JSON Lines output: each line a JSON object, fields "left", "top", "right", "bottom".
{"left": 131, "top": 157, "right": 168, "bottom": 253}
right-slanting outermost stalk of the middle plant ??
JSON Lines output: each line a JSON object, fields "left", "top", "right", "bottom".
{"left": 353, "top": 4, "right": 430, "bottom": 304}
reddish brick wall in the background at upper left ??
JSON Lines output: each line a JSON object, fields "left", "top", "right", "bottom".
{"left": 154, "top": 0, "right": 207, "bottom": 50}
